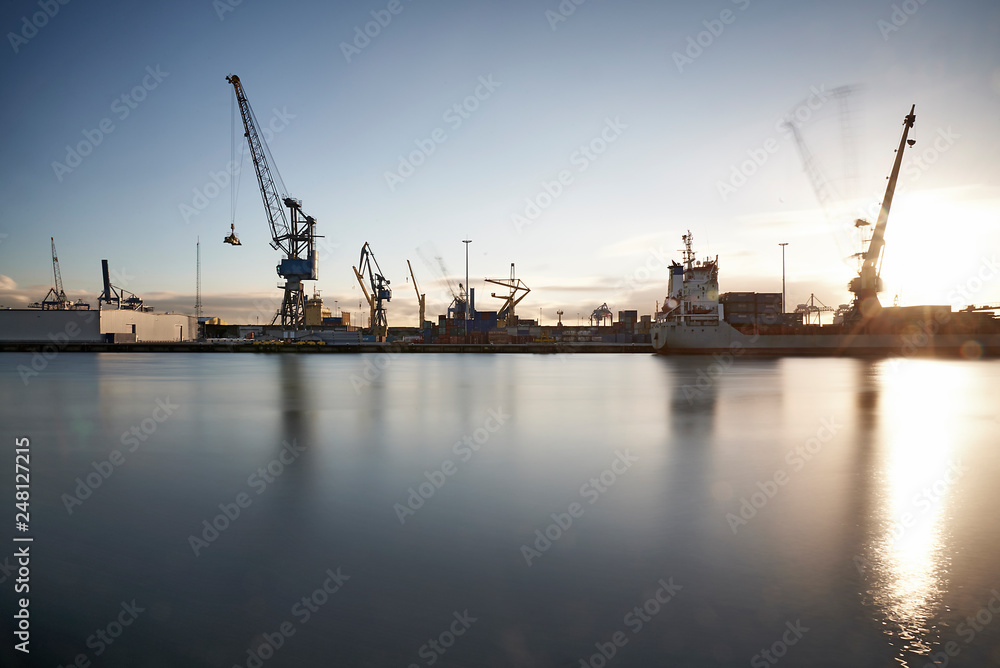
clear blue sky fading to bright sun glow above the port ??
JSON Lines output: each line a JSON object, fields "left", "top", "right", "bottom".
{"left": 0, "top": 0, "right": 1000, "bottom": 326}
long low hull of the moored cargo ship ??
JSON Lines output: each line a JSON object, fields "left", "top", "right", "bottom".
{"left": 650, "top": 321, "right": 1000, "bottom": 357}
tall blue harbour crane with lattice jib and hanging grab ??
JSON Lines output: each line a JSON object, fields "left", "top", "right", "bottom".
{"left": 226, "top": 74, "right": 319, "bottom": 329}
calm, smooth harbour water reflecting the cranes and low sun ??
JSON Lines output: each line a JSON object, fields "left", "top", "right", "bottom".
{"left": 0, "top": 354, "right": 1000, "bottom": 668}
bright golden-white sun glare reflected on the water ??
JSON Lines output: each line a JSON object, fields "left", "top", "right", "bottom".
{"left": 869, "top": 360, "right": 961, "bottom": 665}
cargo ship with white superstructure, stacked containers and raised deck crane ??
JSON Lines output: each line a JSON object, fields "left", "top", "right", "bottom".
{"left": 650, "top": 105, "right": 1000, "bottom": 358}
